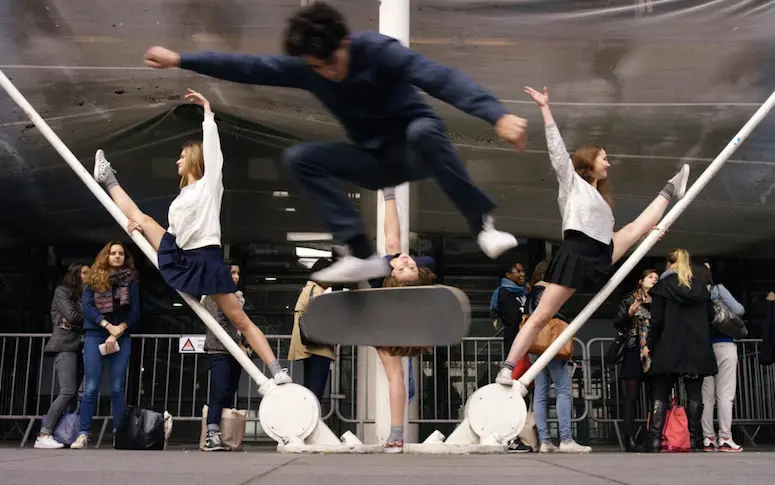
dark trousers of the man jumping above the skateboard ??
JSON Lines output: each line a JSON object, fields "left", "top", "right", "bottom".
{"left": 283, "top": 118, "right": 495, "bottom": 250}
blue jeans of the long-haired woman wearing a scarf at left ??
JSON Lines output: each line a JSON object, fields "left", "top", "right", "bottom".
{"left": 81, "top": 334, "right": 132, "bottom": 434}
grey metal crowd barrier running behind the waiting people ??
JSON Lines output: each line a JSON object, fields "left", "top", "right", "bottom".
{"left": 0, "top": 334, "right": 775, "bottom": 447}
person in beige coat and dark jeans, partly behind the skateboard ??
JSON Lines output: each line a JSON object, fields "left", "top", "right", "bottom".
{"left": 288, "top": 258, "right": 336, "bottom": 401}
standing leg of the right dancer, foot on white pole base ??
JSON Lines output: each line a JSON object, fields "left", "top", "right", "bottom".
{"left": 495, "top": 283, "right": 576, "bottom": 386}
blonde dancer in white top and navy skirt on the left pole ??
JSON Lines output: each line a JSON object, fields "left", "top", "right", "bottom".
{"left": 94, "top": 89, "right": 291, "bottom": 384}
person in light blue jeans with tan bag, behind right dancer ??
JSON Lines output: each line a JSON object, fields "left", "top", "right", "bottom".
{"left": 525, "top": 261, "right": 592, "bottom": 453}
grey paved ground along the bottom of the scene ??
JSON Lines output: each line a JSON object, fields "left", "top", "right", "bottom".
{"left": 0, "top": 448, "right": 775, "bottom": 485}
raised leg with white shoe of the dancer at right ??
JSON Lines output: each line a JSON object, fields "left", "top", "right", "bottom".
{"left": 611, "top": 165, "right": 689, "bottom": 263}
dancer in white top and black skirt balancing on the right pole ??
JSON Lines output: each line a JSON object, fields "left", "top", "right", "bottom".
{"left": 495, "top": 87, "right": 689, "bottom": 386}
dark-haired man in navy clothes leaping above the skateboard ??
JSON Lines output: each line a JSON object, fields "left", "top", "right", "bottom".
{"left": 145, "top": 2, "right": 527, "bottom": 283}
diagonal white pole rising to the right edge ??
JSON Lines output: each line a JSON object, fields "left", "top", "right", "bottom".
{"left": 519, "top": 92, "right": 775, "bottom": 388}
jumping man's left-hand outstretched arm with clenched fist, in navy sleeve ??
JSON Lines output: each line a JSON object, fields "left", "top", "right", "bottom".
{"left": 145, "top": 47, "right": 311, "bottom": 89}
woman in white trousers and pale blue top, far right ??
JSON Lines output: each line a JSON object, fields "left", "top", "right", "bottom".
{"left": 702, "top": 261, "right": 745, "bottom": 453}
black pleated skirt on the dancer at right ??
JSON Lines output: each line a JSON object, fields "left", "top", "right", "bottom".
{"left": 544, "top": 230, "right": 614, "bottom": 291}
